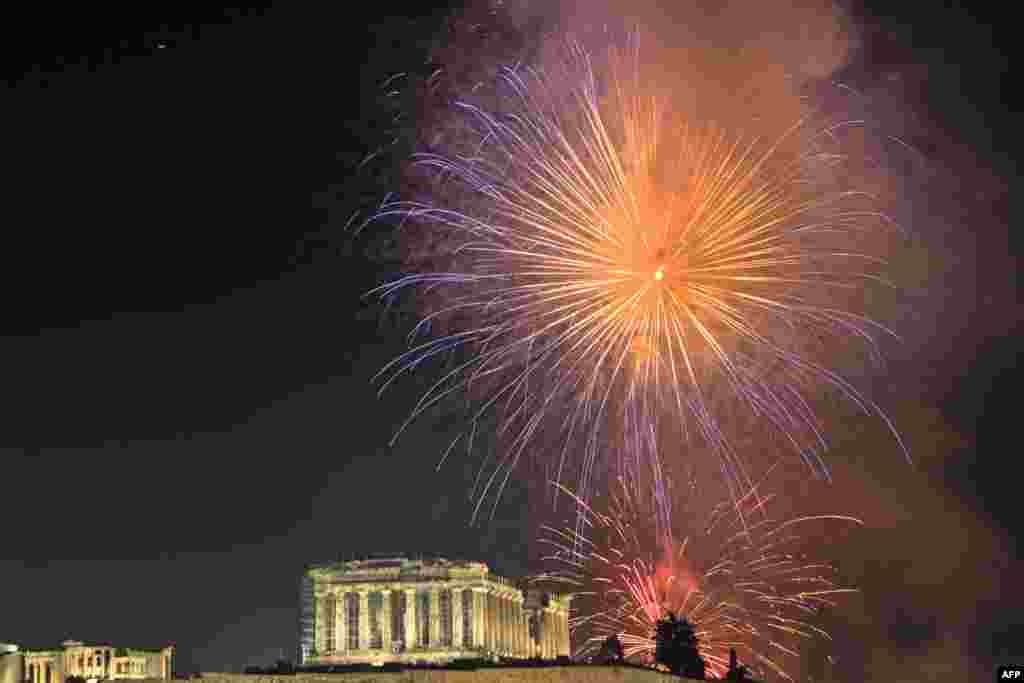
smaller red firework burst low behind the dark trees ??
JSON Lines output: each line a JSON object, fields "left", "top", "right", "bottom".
{"left": 534, "top": 473, "right": 862, "bottom": 680}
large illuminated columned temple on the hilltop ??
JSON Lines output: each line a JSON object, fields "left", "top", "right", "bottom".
{"left": 299, "top": 558, "right": 570, "bottom": 667}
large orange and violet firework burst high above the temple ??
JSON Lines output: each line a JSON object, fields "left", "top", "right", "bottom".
{"left": 366, "top": 30, "right": 898, "bottom": 521}
